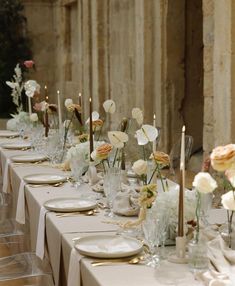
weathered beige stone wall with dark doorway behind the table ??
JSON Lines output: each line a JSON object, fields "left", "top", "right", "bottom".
{"left": 23, "top": 0, "right": 207, "bottom": 154}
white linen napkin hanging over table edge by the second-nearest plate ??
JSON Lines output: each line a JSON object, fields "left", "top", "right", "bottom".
{"left": 36, "top": 206, "right": 48, "bottom": 259}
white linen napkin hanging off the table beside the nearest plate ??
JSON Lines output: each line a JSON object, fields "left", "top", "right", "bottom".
{"left": 67, "top": 248, "right": 82, "bottom": 286}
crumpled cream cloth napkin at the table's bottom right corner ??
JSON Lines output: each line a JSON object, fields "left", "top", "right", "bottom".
{"left": 196, "top": 235, "right": 235, "bottom": 286}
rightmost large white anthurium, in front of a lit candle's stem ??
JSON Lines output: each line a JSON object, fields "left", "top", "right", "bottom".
{"left": 136, "top": 124, "right": 158, "bottom": 145}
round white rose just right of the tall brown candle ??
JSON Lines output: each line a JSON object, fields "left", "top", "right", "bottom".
{"left": 193, "top": 172, "right": 217, "bottom": 194}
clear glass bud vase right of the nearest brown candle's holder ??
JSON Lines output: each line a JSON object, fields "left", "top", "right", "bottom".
{"left": 188, "top": 232, "right": 208, "bottom": 272}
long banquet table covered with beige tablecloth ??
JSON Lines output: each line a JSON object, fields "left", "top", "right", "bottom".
{"left": 0, "top": 135, "right": 206, "bottom": 286}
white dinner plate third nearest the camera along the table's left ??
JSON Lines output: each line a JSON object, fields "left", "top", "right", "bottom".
{"left": 24, "top": 174, "right": 67, "bottom": 184}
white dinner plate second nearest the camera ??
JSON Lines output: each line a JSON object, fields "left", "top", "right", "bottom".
{"left": 44, "top": 198, "right": 96, "bottom": 212}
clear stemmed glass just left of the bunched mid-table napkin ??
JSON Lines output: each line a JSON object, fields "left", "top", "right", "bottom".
{"left": 104, "top": 167, "right": 121, "bottom": 217}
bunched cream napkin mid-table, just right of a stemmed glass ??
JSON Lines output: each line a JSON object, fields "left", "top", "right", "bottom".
{"left": 113, "top": 188, "right": 140, "bottom": 216}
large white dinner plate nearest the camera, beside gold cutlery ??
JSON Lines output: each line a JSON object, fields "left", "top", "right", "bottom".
{"left": 74, "top": 235, "right": 143, "bottom": 258}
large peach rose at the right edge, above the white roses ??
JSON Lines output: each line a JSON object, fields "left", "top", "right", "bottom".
{"left": 210, "top": 144, "right": 235, "bottom": 172}
